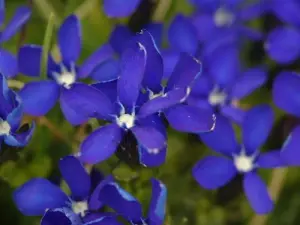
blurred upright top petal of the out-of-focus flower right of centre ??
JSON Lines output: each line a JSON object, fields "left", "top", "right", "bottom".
{"left": 208, "top": 46, "right": 240, "bottom": 88}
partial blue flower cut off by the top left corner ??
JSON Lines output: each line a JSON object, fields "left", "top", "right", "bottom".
{"left": 0, "top": 0, "right": 31, "bottom": 78}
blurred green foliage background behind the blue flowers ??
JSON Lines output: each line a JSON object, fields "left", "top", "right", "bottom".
{"left": 0, "top": 0, "right": 300, "bottom": 225}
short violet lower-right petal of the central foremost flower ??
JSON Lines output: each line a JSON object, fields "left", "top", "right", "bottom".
{"left": 131, "top": 125, "right": 167, "bottom": 149}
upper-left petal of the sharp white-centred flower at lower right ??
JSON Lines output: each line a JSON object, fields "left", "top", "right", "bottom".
{"left": 199, "top": 115, "right": 239, "bottom": 156}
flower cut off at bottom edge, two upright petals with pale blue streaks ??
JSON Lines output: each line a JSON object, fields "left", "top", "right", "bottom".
{"left": 99, "top": 179, "right": 167, "bottom": 225}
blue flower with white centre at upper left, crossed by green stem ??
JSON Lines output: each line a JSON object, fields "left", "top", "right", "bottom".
{"left": 19, "top": 15, "right": 113, "bottom": 125}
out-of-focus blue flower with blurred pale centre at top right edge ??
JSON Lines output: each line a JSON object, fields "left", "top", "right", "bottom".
{"left": 191, "top": 0, "right": 266, "bottom": 42}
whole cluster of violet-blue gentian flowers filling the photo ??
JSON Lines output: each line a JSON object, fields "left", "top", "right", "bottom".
{"left": 0, "top": 0, "right": 300, "bottom": 225}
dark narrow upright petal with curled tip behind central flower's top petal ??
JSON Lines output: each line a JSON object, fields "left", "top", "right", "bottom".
{"left": 136, "top": 30, "right": 164, "bottom": 92}
